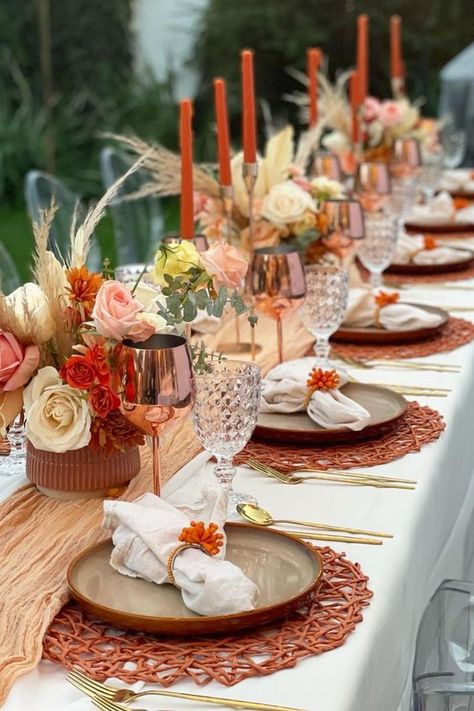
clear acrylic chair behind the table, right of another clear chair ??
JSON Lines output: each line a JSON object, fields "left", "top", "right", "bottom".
{"left": 100, "top": 146, "right": 163, "bottom": 265}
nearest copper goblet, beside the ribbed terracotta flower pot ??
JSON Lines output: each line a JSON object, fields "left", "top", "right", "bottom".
{"left": 121, "top": 334, "right": 194, "bottom": 496}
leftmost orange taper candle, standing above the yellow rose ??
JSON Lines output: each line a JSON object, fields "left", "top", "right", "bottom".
{"left": 179, "top": 99, "right": 194, "bottom": 239}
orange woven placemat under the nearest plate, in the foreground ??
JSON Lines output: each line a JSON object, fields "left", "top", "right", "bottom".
{"left": 43, "top": 548, "right": 372, "bottom": 687}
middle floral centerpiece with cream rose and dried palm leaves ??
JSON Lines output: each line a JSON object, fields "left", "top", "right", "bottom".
{"left": 112, "top": 126, "right": 344, "bottom": 262}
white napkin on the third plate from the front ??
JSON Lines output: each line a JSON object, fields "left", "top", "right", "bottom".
{"left": 343, "top": 289, "right": 442, "bottom": 331}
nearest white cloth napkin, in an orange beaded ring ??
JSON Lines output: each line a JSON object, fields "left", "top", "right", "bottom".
{"left": 102, "top": 490, "right": 258, "bottom": 615}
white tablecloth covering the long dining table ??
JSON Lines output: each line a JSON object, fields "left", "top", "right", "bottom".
{"left": 0, "top": 280, "right": 474, "bottom": 711}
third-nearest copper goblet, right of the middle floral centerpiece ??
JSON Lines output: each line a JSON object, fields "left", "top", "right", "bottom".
{"left": 321, "top": 199, "right": 365, "bottom": 266}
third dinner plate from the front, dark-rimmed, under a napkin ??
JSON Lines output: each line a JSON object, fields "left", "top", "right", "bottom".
{"left": 331, "top": 302, "right": 449, "bottom": 345}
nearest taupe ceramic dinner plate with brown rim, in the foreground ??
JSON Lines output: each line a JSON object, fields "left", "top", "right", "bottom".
{"left": 67, "top": 523, "right": 323, "bottom": 636}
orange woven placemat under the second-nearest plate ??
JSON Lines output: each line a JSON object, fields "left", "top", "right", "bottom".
{"left": 235, "top": 402, "right": 445, "bottom": 472}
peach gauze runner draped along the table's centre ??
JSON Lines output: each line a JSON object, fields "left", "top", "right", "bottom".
{"left": 0, "top": 316, "right": 312, "bottom": 704}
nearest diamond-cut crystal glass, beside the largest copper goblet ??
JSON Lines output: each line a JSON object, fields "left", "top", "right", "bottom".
{"left": 192, "top": 360, "right": 261, "bottom": 519}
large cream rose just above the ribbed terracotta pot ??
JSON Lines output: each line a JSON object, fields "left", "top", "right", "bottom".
{"left": 25, "top": 367, "right": 91, "bottom": 453}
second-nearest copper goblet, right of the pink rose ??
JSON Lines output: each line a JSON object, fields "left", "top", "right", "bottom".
{"left": 247, "top": 244, "right": 306, "bottom": 363}
